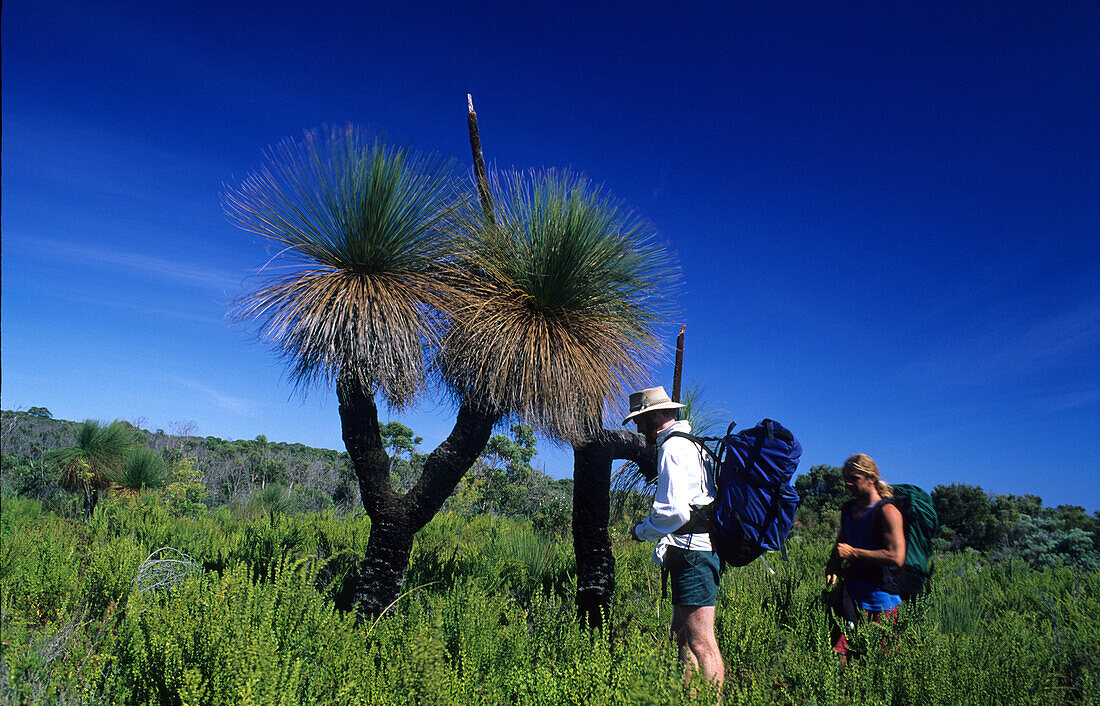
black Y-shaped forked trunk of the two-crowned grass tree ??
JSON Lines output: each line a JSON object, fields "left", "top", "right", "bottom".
{"left": 337, "top": 383, "right": 499, "bottom": 619}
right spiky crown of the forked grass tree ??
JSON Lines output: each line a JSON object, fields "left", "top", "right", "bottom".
{"left": 441, "top": 172, "right": 678, "bottom": 441}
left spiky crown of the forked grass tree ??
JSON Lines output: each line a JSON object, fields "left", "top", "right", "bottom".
{"left": 223, "top": 126, "right": 459, "bottom": 408}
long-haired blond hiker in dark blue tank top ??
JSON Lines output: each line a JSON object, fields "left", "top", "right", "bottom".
{"left": 825, "top": 453, "right": 905, "bottom": 663}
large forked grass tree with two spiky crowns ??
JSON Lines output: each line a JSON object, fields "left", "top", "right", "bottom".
{"left": 224, "top": 128, "right": 666, "bottom": 615}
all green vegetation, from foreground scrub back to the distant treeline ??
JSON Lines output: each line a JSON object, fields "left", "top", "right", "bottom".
{"left": 0, "top": 408, "right": 1100, "bottom": 704}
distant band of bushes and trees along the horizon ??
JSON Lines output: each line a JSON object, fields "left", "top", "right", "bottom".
{"left": 0, "top": 407, "right": 1100, "bottom": 570}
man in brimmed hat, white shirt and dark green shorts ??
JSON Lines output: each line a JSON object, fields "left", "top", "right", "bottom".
{"left": 623, "top": 387, "right": 725, "bottom": 686}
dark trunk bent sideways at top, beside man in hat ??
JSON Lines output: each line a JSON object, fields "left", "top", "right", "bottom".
{"left": 573, "top": 429, "right": 657, "bottom": 627}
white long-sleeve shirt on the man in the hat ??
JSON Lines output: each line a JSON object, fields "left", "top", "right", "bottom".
{"left": 635, "top": 421, "right": 715, "bottom": 564}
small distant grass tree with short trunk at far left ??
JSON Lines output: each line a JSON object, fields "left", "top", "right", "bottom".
{"left": 47, "top": 419, "right": 136, "bottom": 519}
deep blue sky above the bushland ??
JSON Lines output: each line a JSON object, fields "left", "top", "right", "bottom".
{"left": 0, "top": 1, "right": 1100, "bottom": 510}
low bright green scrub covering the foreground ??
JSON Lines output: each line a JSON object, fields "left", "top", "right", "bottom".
{"left": 0, "top": 494, "right": 1100, "bottom": 704}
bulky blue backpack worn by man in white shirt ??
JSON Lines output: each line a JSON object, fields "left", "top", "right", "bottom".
{"left": 673, "top": 419, "right": 802, "bottom": 566}
